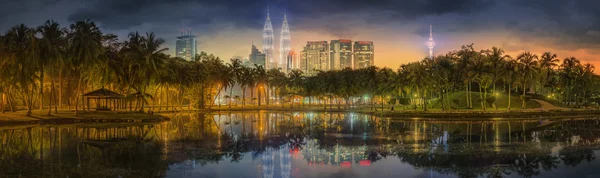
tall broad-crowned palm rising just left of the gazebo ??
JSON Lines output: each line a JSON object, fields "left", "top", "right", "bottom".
{"left": 68, "top": 20, "right": 103, "bottom": 115}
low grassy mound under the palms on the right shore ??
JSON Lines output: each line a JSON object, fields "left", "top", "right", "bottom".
{"left": 433, "top": 91, "right": 541, "bottom": 110}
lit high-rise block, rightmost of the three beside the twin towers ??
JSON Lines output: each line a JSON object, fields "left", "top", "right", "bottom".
{"left": 354, "top": 41, "right": 375, "bottom": 69}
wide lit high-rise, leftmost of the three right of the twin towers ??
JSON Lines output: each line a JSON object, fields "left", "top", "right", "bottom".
{"left": 300, "top": 41, "right": 331, "bottom": 76}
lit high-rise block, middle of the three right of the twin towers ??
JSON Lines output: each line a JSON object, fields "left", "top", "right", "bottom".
{"left": 329, "top": 39, "right": 352, "bottom": 70}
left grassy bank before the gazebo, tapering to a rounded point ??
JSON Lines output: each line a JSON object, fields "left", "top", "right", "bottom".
{"left": 0, "top": 110, "right": 169, "bottom": 126}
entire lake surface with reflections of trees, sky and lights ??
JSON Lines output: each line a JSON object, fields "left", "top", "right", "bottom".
{"left": 0, "top": 112, "right": 600, "bottom": 178}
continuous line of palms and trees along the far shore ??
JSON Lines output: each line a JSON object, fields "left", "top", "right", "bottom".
{"left": 0, "top": 20, "right": 600, "bottom": 115}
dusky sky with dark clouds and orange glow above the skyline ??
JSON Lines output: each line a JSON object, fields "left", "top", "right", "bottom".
{"left": 0, "top": 0, "right": 600, "bottom": 69}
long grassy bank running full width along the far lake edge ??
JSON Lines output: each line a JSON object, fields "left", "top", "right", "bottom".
{"left": 0, "top": 105, "right": 600, "bottom": 126}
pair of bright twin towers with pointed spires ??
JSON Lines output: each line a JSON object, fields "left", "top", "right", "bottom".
{"left": 263, "top": 8, "right": 291, "bottom": 69}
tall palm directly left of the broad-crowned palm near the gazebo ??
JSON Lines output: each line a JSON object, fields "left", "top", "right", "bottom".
{"left": 38, "top": 20, "right": 65, "bottom": 115}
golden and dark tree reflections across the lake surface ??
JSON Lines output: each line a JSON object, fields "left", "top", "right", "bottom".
{"left": 0, "top": 113, "right": 600, "bottom": 177}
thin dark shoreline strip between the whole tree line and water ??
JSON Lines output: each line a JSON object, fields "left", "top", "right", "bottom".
{"left": 0, "top": 107, "right": 600, "bottom": 127}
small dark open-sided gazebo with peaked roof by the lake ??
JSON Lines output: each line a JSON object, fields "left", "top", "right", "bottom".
{"left": 83, "top": 88, "right": 123, "bottom": 111}
